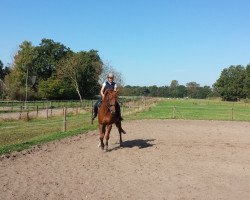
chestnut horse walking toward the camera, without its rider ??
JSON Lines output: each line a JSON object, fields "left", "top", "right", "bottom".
{"left": 98, "top": 90, "right": 126, "bottom": 151}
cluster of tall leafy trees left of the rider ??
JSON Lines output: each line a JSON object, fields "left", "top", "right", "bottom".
{"left": 2, "top": 39, "right": 103, "bottom": 100}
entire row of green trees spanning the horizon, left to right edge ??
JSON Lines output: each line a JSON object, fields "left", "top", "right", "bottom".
{"left": 0, "top": 39, "right": 250, "bottom": 101}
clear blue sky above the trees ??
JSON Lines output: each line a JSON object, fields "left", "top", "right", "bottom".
{"left": 0, "top": 0, "right": 250, "bottom": 86}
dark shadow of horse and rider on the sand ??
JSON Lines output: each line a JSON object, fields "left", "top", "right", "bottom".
{"left": 109, "top": 139, "right": 155, "bottom": 151}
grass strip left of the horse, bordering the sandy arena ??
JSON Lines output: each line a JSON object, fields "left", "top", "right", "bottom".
{"left": 0, "top": 113, "right": 97, "bottom": 155}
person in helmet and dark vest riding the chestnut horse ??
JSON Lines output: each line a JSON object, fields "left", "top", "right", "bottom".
{"left": 92, "top": 72, "right": 123, "bottom": 120}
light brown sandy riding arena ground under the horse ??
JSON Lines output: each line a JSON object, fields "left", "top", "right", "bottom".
{"left": 0, "top": 120, "right": 250, "bottom": 200}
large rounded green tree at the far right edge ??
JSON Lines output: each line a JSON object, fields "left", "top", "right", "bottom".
{"left": 213, "top": 65, "right": 246, "bottom": 101}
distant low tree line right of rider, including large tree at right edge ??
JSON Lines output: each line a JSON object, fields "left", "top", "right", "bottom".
{"left": 123, "top": 64, "right": 250, "bottom": 101}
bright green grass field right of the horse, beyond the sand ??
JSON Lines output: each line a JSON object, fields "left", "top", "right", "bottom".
{"left": 128, "top": 100, "right": 250, "bottom": 121}
